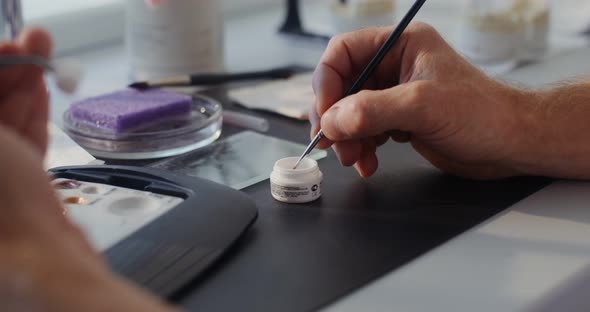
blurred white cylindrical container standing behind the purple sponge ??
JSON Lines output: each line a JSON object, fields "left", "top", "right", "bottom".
{"left": 126, "top": 0, "right": 224, "bottom": 80}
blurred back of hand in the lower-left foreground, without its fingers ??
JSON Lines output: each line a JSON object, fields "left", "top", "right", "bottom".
{"left": 0, "top": 123, "right": 178, "bottom": 312}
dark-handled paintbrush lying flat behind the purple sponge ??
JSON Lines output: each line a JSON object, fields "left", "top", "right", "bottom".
{"left": 129, "top": 66, "right": 298, "bottom": 89}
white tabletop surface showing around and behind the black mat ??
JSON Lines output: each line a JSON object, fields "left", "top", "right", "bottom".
{"left": 51, "top": 0, "right": 590, "bottom": 311}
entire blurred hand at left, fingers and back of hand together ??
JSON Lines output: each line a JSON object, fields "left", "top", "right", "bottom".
{"left": 0, "top": 29, "right": 177, "bottom": 311}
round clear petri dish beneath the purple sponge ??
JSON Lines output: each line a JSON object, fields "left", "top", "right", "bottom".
{"left": 63, "top": 95, "right": 222, "bottom": 159}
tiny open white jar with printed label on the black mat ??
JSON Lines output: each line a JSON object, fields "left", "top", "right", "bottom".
{"left": 270, "top": 157, "right": 323, "bottom": 204}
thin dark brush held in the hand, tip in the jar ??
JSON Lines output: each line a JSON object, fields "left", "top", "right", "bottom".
{"left": 293, "top": 0, "right": 426, "bottom": 169}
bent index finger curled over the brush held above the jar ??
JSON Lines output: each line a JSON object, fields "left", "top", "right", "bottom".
{"left": 313, "top": 22, "right": 434, "bottom": 117}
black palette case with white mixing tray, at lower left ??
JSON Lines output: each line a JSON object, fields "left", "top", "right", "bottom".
{"left": 49, "top": 166, "right": 257, "bottom": 297}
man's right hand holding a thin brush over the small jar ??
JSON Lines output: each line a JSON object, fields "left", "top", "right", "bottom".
{"left": 310, "top": 23, "right": 525, "bottom": 179}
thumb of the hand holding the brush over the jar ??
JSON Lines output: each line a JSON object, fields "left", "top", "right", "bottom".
{"left": 321, "top": 81, "right": 436, "bottom": 141}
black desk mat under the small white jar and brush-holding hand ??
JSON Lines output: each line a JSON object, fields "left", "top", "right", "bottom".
{"left": 164, "top": 89, "right": 550, "bottom": 311}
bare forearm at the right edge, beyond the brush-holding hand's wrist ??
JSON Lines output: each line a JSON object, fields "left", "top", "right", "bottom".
{"left": 514, "top": 81, "right": 590, "bottom": 179}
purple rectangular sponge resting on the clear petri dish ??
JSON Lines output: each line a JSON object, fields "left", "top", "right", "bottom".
{"left": 70, "top": 89, "right": 192, "bottom": 133}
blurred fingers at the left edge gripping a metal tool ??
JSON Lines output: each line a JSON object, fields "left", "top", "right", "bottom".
{"left": 0, "top": 29, "right": 51, "bottom": 155}
